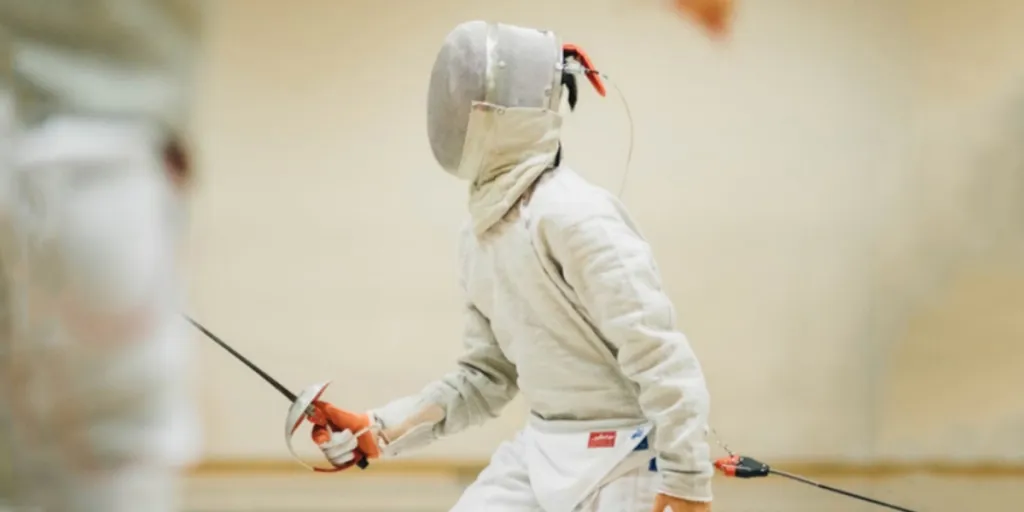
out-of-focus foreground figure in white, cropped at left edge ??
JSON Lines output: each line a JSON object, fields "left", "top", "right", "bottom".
{"left": 0, "top": 0, "right": 200, "bottom": 512}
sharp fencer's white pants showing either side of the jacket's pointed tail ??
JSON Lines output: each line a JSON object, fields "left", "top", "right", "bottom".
{"left": 450, "top": 435, "right": 658, "bottom": 512}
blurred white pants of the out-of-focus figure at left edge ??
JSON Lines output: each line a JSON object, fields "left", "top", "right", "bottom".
{"left": 0, "top": 118, "right": 198, "bottom": 512}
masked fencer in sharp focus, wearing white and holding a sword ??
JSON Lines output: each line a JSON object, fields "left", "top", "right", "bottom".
{"left": 313, "top": 22, "right": 713, "bottom": 512}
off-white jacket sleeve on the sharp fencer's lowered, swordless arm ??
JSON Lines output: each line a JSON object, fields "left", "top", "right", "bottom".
{"left": 541, "top": 206, "right": 714, "bottom": 502}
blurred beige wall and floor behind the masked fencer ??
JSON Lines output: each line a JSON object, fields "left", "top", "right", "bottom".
{"left": 182, "top": 0, "right": 1024, "bottom": 512}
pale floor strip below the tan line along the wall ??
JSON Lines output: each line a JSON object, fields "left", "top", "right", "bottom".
{"left": 188, "top": 474, "right": 1024, "bottom": 512}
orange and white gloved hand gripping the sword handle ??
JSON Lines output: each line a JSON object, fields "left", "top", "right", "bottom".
{"left": 312, "top": 401, "right": 381, "bottom": 468}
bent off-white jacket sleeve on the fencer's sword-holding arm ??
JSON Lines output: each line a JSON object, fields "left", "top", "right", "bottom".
{"left": 371, "top": 299, "right": 519, "bottom": 456}
